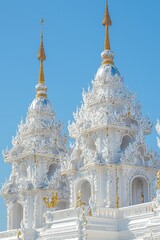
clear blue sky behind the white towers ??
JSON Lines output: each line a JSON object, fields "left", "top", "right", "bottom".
{"left": 0, "top": 0, "right": 160, "bottom": 230}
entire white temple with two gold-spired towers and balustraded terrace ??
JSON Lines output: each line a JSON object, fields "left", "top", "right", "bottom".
{"left": 0, "top": 3, "right": 160, "bottom": 240}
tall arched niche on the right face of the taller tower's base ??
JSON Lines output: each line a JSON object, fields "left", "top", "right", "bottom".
{"left": 131, "top": 176, "right": 149, "bottom": 205}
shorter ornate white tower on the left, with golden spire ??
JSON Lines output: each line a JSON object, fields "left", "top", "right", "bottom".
{"left": 2, "top": 21, "right": 69, "bottom": 239}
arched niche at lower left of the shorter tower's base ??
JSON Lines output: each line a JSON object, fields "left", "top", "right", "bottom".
{"left": 11, "top": 202, "right": 23, "bottom": 229}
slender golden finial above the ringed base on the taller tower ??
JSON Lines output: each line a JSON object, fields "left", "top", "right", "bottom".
{"left": 102, "top": 1, "right": 112, "bottom": 50}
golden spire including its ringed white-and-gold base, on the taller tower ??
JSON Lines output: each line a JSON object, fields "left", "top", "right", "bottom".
{"left": 102, "top": 0, "right": 113, "bottom": 64}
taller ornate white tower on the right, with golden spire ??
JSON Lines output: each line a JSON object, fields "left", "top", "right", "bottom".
{"left": 62, "top": 2, "right": 160, "bottom": 209}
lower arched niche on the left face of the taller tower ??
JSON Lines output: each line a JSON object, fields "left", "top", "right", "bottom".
{"left": 77, "top": 180, "right": 91, "bottom": 206}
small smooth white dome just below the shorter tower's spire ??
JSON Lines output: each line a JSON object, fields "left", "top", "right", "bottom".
{"left": 29, "top": 98, "right": 53, "bottom": 113}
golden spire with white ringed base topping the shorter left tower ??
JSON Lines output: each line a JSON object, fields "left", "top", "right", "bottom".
{"left": 36, "top": 19, "right": 47, "bottom": 98}
